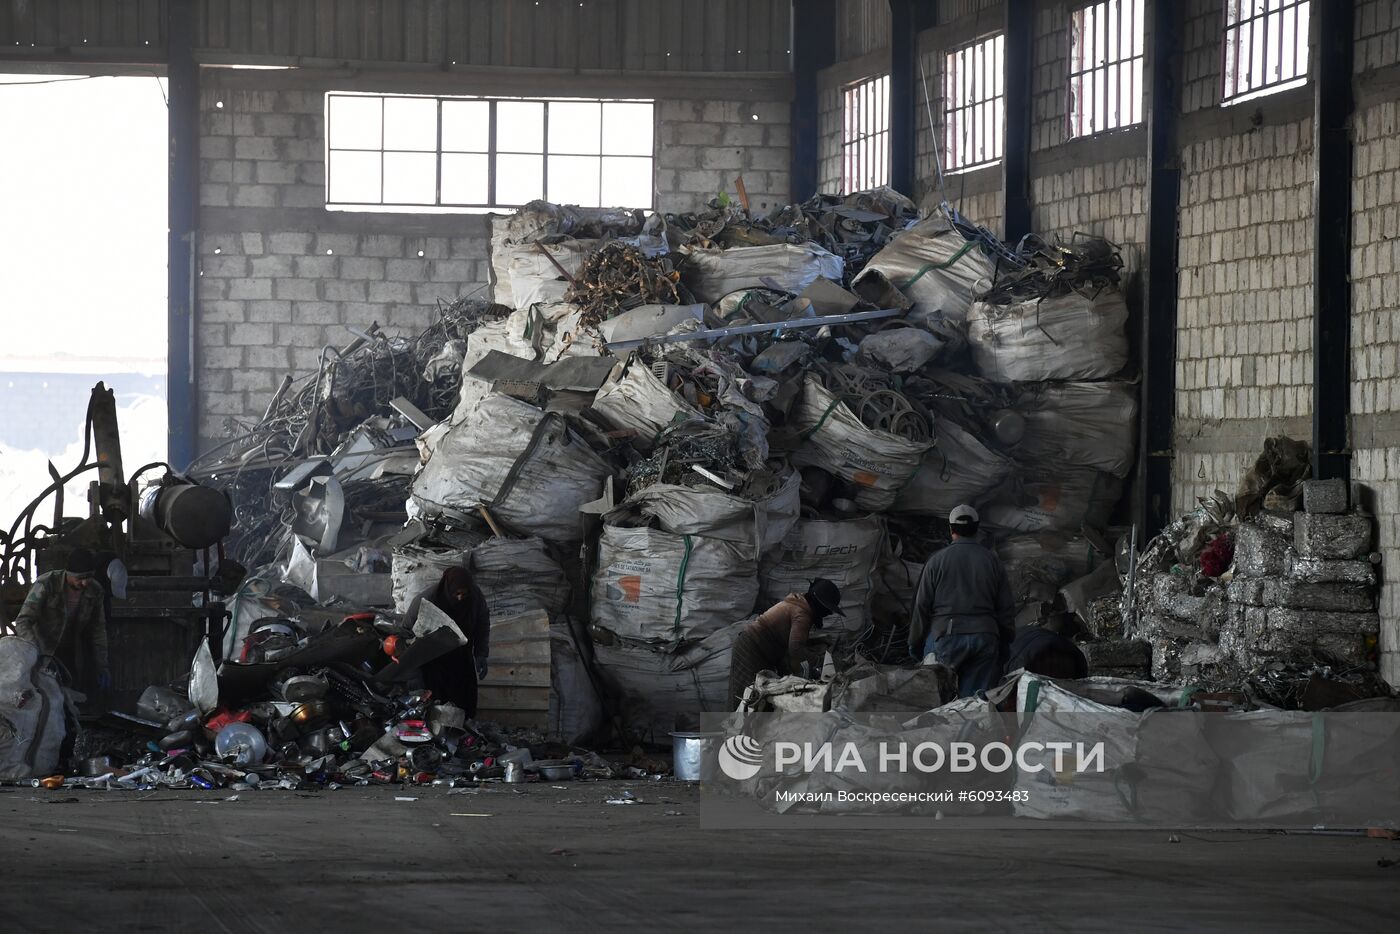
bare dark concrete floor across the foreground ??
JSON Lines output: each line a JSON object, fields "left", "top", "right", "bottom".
{"left": 0, "top": 783, "right": 1400, "bottom": 934}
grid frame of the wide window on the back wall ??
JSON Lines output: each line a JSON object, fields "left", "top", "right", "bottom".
{"left": 322, "top": 91, "right": 657, "bottom": 214}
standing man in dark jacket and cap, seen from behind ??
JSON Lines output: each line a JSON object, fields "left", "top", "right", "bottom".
{"left": 909, "top": 506, "right": 1016, "bottom": 697}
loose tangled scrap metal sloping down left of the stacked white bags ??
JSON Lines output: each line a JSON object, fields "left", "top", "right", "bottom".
{"left": 190, "top": 300, "right": 510, "bottom": 576}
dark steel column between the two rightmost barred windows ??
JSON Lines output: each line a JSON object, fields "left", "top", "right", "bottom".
{"left": 1134, "top": 0, "right": 1182, "bottom": 542}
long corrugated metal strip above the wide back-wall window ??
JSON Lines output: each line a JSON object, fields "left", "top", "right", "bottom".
{"left": 197, "top": 0, "right": 790, "bottom": 71}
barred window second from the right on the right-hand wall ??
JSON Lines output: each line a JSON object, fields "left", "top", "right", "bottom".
{"left": 1070, "top": 0, "right": 1142, "bottom": 136}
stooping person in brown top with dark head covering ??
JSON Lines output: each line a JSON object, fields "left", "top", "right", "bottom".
{"left": 729, "top": 577, "right": 846, "bottom": 709}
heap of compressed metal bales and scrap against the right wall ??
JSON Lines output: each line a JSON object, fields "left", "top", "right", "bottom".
{"left": 1100, "top": 437, "right": 1390, "bottom": 710}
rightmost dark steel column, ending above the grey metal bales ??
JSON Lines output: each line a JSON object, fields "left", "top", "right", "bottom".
{"left": 1312, "top": 0, "right": 1354, "bottom": 480}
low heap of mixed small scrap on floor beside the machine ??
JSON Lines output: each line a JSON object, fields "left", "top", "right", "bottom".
{"left": 35, "top": 605, "right": 623, "bottom": 791}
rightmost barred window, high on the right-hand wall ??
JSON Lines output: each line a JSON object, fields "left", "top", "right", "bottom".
{"left": 1221, "top": 0, "right": 1310, "bottom": 104}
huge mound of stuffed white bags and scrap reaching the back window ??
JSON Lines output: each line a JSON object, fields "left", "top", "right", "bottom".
{"left": 177, "top": 190, "right": 1137, "bottom": 744}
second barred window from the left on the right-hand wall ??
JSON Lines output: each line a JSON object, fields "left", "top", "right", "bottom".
{"left": 944, "top": 35, "right": 1007, "bottom": 171}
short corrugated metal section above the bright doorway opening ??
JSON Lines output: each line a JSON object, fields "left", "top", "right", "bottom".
{"left": 0, "top": 0, "right": 165, "bottom": 50}
